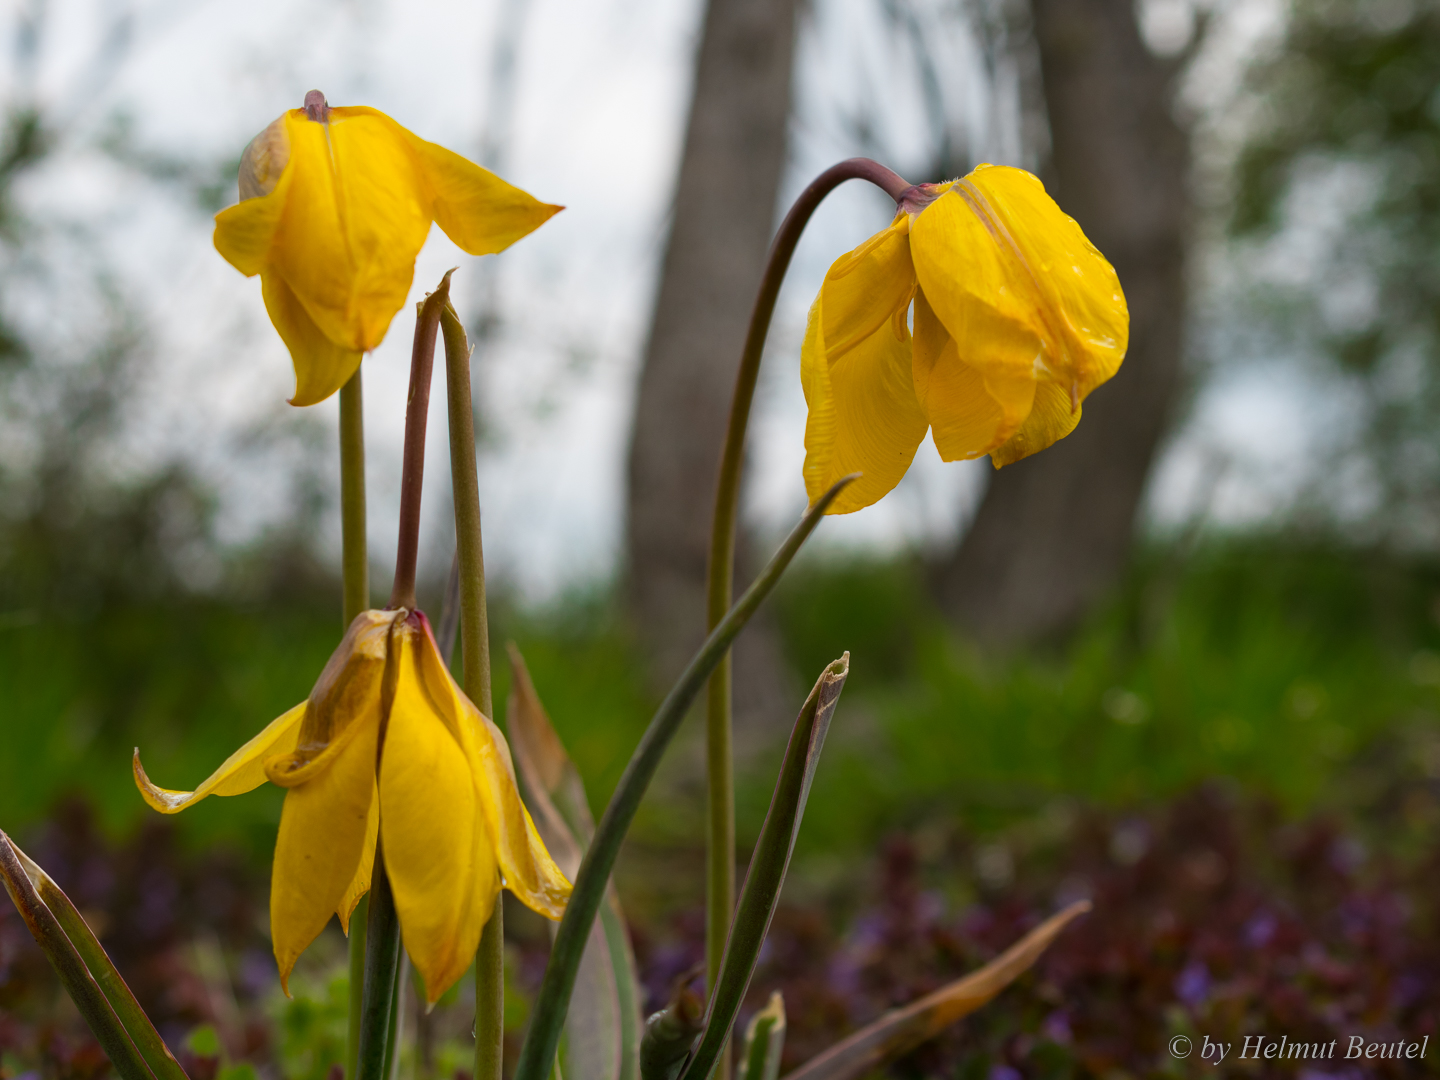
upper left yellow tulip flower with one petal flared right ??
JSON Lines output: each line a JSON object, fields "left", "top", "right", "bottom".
{"left": 215, "top": 91, "right": 563, "bottom": 405}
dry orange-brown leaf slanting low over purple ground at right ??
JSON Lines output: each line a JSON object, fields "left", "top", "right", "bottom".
{"left": 785, "top": 900, "right": 1090, "bottom": 1080}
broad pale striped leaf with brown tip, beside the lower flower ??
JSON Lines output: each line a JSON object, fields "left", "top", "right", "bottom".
{"left": 505, "top": 642, "right": 641, "bottom": 1080}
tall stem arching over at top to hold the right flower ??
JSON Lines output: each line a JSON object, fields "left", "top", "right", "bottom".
{"left": 706, "top": 157, "right": 910, "bottom": 1013}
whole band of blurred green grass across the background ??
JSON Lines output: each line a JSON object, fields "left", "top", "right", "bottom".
{"left": 0, "top": 537, "right": 1440, "bottom": 858}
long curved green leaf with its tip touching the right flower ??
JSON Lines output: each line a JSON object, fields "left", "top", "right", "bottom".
{"left": 514, "top": 477, "right": 854, "bottom": 1080}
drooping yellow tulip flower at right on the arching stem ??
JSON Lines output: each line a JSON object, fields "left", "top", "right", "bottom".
{"left": 801, "top": 166, "right": 1130, "bottom": 514}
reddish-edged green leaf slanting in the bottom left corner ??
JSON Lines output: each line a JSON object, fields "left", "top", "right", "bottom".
{"left": 0, "top": 832, "right": 186, "bottom": 1080}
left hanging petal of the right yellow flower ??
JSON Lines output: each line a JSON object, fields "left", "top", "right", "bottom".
{"left": 801, "top": 215, "right": 927, "bottom": 514}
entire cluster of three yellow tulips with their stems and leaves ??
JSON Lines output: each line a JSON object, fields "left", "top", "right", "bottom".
{"left": 0, "top": 91, "right": 1128, "bottom": 1080}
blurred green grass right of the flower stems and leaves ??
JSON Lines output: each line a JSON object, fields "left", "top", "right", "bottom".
{"left": 782, "top": 537, "right": 1440, "bottom": 851}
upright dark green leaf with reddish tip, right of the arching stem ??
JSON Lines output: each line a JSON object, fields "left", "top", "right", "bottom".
{"left": 681, "top": 652, "right": 850, "bottom": 1080}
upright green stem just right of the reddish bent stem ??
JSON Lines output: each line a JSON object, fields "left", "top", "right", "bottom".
{"left": 441, "top": 300, "right": 505, "bottom": 1080}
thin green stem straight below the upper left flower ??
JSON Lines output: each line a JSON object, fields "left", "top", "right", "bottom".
{"left": 340, "top": 369, "right": 370, "bottom": 1080}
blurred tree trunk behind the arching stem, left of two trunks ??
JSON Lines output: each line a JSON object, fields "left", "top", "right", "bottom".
{"left": 625, "top": 0, "right": 798, "bottom": 694}
